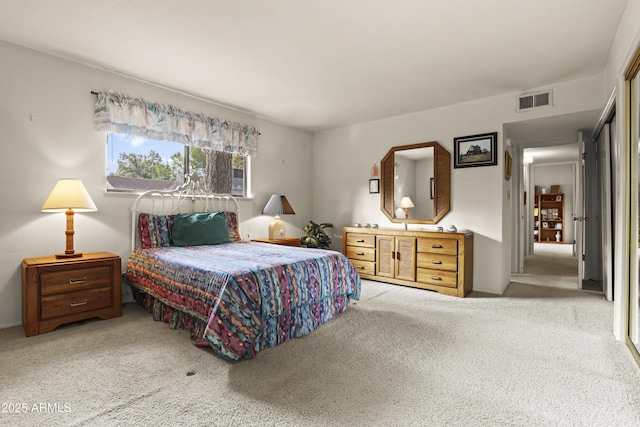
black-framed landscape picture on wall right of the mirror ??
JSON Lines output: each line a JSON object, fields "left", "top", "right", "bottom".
{"left": 453, "top": 132, "right": 498, "bottom": 169}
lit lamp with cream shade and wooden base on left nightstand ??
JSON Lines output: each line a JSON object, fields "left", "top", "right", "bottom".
{"left": 40, "top": 179, "right": 98, "bottom": 258}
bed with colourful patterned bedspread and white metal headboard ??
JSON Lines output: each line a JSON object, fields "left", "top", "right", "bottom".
{"left": 126, "top": 175, "right": 360, "bottom": 362}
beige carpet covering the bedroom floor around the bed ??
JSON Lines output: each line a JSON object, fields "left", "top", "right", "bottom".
{"left": 0, "top": 281, "right": 640, "bottom": 426}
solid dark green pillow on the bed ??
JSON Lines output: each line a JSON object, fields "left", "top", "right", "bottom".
{"left": 173, "top": 212, "right": 231, "bottom": 246}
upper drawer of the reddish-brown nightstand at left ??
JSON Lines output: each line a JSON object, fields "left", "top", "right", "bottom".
{"left": 40, "top": 267, "right": 112, "bottom": 295}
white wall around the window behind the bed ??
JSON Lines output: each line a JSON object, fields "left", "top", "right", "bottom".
{"left": 0, "top": 42, "right": 314, "bottom": 328}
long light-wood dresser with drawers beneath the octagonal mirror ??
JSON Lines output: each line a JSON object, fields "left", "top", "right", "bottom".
{"left": 342, "top": 227, "right": 473, "bottom": 297}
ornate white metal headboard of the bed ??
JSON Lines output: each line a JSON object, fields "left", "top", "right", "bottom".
{"left": 131, "top": 173, "right": 240, "bottom": 250}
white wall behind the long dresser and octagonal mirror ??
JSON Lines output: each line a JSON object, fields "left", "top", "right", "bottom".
{"left": 313, "top": 76, "right": 604, "bottom": 294}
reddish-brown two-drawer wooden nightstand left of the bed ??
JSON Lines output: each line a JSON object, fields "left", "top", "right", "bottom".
{"left": 22, "top": 252, "right": 122, "bottom": 337}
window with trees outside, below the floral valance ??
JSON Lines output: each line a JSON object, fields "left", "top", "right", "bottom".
{"left": 106, "top": 132, "right": 247, "bottom": 197}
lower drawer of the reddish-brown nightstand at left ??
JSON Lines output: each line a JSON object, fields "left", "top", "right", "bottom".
{"left": 40, "top": 287, "right": 113, "bottom": 320}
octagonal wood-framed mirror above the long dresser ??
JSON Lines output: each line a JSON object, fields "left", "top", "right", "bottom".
{"left": 380, "top": 141, "right": 451, "bottom": 224}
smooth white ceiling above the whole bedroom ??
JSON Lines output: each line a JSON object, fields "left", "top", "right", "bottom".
{"left": 0, "top": 0, "right": 626, "bottom": 135}
